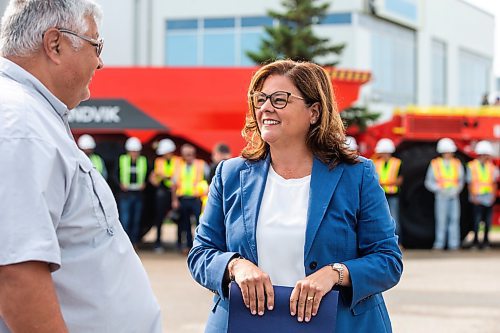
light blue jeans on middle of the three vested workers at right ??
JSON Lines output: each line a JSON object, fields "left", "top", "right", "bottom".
{"left": 433, "top": 194, "right": 460, "bottom": 250}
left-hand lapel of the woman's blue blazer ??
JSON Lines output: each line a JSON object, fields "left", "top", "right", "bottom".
{"left": 240, "top": 154, "right": 270, "bottom": 264}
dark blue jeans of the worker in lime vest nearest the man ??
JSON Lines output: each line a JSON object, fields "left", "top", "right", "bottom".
{"left": 118, "top": 191, "right": 142, "bottom": 244}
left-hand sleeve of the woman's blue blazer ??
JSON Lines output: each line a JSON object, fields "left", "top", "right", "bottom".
{"left": 188, "top": 161, "right": 238, "bottom": 297}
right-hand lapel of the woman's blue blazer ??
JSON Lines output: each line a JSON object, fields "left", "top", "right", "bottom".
{"left": 304, "top": 158, "right": 344, "bottom": 258}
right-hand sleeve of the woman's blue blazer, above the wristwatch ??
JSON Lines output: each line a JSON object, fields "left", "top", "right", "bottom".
{"left": 343, "top": 160, "right": 403, "bottom": 309}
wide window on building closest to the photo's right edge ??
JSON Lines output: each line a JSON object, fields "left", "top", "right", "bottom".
{"left": 459, "top": 49, "right": 492, "bottom": 106}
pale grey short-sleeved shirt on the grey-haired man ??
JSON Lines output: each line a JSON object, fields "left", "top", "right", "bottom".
{"left": 0, "top": 57, "right": 162, "bottom": 333}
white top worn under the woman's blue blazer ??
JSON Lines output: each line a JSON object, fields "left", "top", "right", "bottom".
{"left": 257, "top": 166, "right": 311, "bottom": 287}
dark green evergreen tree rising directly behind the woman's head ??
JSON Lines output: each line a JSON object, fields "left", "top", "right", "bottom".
{"left": 246, "top": 0, "right": 344, "bottom": 66}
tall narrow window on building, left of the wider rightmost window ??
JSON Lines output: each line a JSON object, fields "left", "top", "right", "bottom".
{"left": 430, "top": 40, "right": 447, "bottom": 105}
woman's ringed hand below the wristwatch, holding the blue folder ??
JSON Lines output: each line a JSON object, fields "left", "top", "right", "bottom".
{"left": 290, "top": 266, "right": 339, "bottom": 322}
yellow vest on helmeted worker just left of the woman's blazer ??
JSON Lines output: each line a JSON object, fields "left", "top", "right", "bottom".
{"left": 175, "top": 159, "right": 208, "bottom": 197}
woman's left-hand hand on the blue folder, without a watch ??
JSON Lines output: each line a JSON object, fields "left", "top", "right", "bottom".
{"left": 228, "top": 258, "right": 274, "bottom": 316}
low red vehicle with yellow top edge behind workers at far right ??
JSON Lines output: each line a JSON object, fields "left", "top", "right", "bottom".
{"left": 350, "top": 106, "right": 500, "bottom": 248}
